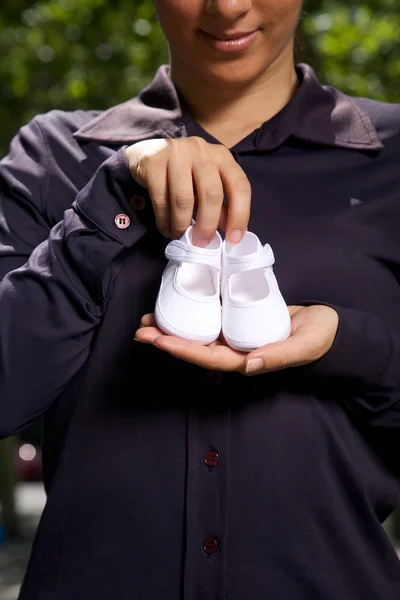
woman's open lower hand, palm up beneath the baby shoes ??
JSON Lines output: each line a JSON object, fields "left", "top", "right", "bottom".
{"left": 135, "top": 305, "right": 339, "bottom": 375}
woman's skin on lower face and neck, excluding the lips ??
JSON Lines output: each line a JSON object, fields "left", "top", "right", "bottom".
{"left": 154, "top": 0, "right": 302, "bottom": 141}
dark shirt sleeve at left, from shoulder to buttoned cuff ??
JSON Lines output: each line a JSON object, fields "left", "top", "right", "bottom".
{"left": 0, "top": 115, "right": 150, "bottom": 438}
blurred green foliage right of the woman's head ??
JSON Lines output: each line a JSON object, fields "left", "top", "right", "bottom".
{"left": 302, "top": 0, "right": 400, "bottom": 102}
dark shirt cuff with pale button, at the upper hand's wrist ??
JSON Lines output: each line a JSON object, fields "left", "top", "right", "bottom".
{"left": 72, "top": 147, "right": 152, "bottom": 248}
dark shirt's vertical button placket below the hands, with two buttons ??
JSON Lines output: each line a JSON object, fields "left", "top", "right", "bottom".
{"left": 184, "top": 371, "right": 230, "bottom": 600}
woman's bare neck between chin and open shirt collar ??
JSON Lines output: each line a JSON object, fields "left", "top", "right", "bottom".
{"left": 170, "top": 46, "right": 298, "bottom": 147}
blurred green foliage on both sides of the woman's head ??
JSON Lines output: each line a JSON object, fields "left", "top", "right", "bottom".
{"left": 0, "top": 0, "right": 400, "bottom": 154}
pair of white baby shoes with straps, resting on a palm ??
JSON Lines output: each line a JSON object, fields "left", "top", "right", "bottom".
{"left": 154, "top": 225, "right": 291, "bottom": 352}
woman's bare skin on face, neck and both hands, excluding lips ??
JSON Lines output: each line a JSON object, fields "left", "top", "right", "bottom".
{"left": 133, "top": 0, "right": 339, "bottom": 375}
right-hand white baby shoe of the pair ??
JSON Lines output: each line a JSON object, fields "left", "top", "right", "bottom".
{"left": 221, "top": 231, "right": 291, "bottom": 352}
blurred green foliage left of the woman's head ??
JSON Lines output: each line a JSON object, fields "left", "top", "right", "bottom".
{"left": 0, "top": 0, "right": 168, "bottom": 154}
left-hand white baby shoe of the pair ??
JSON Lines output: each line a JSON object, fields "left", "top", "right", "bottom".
{"left": 154, "top": 225, "right": 222, "bottom": 345}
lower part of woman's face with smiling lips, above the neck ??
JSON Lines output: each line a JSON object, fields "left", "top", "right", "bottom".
{"left": 153, "top": 0, "right": 303, "bottom": 86}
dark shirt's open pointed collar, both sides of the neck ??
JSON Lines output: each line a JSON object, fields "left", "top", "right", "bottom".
{"left": 74, "top": 63, "right": 383, "bottom": 151}
